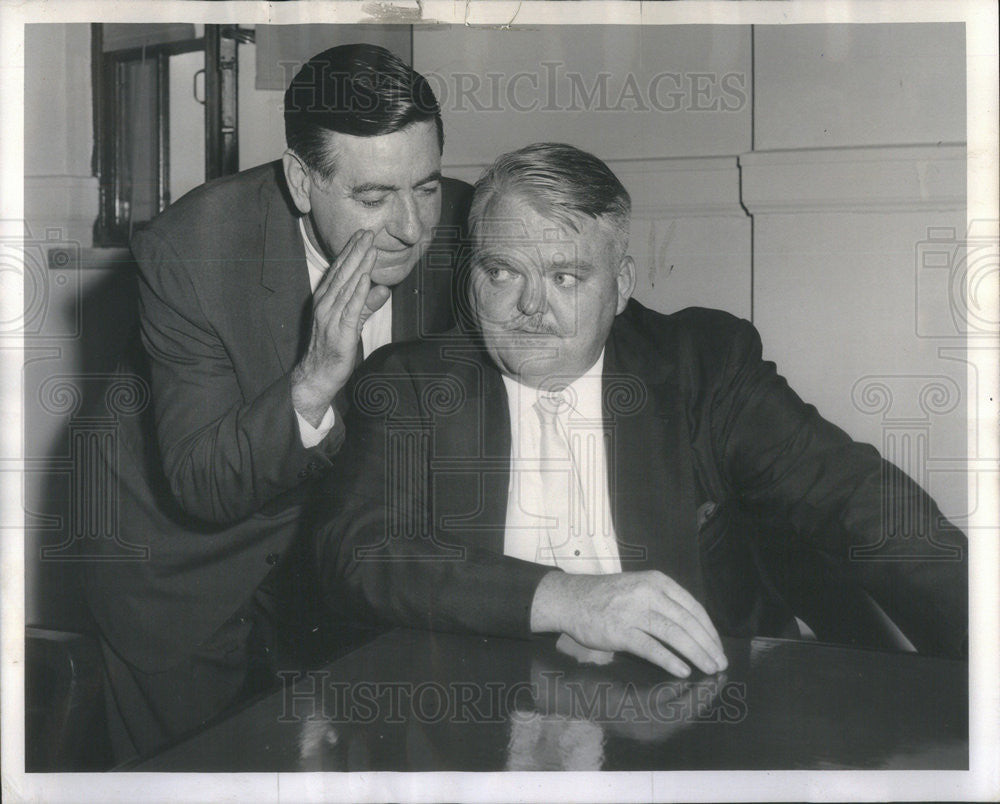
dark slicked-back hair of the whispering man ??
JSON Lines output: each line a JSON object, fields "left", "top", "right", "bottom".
{"left": 285, "top": 43, "right": 444, "bottom": 178}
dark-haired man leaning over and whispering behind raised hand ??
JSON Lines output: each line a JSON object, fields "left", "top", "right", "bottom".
{"left": 84, "top": 45, "right": 471, "bottom": 759}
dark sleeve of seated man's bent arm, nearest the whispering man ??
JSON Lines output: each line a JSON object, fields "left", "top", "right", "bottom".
{"left": 306, "top": 350, "right": 552, "bottom": 637}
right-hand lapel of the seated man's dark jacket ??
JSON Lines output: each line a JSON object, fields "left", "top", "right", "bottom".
{"left": 602, "top": 313, "right": 704, "bottom": 600}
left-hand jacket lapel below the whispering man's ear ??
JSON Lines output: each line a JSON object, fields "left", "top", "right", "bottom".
{"left": 260, "top": 179, "right": 312, "bottom": 373}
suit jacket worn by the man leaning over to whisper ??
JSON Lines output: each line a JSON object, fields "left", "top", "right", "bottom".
{"left": 84, "top": 162, "right": 471, "bottom": 672}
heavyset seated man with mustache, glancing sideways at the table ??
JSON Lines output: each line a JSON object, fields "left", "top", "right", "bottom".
{"left": 309, "top": 144, "right": 967, "bottom": 676}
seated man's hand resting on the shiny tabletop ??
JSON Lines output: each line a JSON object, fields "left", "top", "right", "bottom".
{"left": 531, "top": 571, "right": 728, "bottom": 677}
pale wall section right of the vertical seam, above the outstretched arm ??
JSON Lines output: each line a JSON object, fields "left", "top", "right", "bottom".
{"left": 752, "top": 24, "right": 969, "bottom": 525}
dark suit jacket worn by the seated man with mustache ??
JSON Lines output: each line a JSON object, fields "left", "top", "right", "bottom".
{"left": 308, "top": 300, "right": 967, "bottom": 654}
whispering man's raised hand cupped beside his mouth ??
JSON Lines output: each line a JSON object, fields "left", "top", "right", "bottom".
{"left": 291, "top": 230, "right": 390, "bottom": 427}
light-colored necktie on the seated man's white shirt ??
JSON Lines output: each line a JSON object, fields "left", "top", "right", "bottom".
{"left": 534, "top": 394, "right": 602, "bottom": 574}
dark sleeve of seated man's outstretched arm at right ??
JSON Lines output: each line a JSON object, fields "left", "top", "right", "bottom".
{"left": 702, "top": 319, "right": 968, "bottom": 655}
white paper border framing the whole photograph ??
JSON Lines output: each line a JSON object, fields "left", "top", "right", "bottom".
{"left": 0, "top": 0, "right": 1000, "bottom": 802}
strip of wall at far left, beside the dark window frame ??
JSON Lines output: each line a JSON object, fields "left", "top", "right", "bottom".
{"left": 23, "top": 24, "right": 127, "bottom": 627}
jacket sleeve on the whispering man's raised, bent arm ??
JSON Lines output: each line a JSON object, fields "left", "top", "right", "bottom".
{"left": 132, "top": 223, "right": 343, "bottom": 523}
